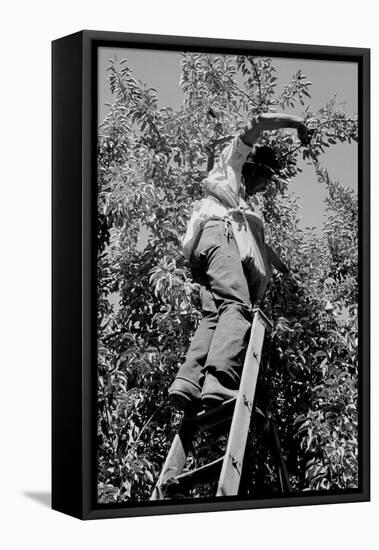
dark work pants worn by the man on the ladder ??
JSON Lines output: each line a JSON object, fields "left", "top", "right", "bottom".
{"left": 177, "top": 220, "right": 252, "bottom": 388}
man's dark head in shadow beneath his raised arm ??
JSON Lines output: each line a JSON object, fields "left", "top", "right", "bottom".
{"left": 242, "top": 145, "right": 281, "bottom": 196}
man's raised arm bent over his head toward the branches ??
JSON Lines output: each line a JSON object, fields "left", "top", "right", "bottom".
{"left": 240, "top": 113, "right": 310, "bottom": 147}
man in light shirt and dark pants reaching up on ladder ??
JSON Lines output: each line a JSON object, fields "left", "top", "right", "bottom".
{"left": 169, "top": 113, "right": 310, "bottom": 411}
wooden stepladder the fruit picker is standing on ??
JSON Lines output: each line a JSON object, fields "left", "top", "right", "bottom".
{"left": 150, "top": 308, "right": 291, "bottom": 500}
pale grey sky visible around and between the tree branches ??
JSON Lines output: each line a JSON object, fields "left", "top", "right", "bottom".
{"left": 98, "top": 48, "right": 358, "bottom": 228}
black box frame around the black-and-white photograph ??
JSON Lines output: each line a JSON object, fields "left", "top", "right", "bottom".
{"left": 52, "top": 30, "right": 370, "bottom": 519}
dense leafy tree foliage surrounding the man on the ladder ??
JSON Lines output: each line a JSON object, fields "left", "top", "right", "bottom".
{"left": 97, "top": 54, "right": 358, "bottom": 502}
